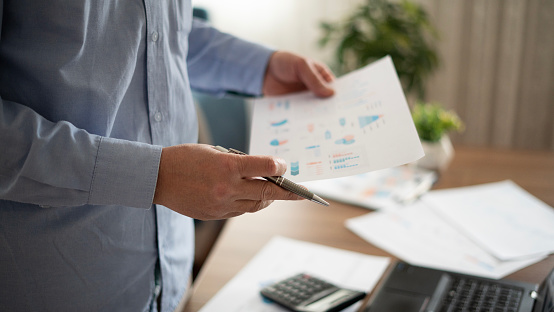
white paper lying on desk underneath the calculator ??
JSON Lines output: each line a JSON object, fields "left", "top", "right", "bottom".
{"left": 200, "top": 236, "right": 390, "bottom": 312}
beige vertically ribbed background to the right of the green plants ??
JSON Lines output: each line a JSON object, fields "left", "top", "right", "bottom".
{"left": 421, "top": 0, "right": 554, "bottom": 150}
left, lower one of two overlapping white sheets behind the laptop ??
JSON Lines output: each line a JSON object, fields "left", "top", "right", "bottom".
{"left": 346, "top": 201, "right": 544, "bottom": 278}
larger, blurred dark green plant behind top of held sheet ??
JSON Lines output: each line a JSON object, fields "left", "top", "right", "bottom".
{"left": 319, "top": 0, "right": 439, "bottom": 99}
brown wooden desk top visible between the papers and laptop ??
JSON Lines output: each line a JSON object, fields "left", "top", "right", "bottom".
{"left": 185, "top": 147, "right": 554, "bottom": 311}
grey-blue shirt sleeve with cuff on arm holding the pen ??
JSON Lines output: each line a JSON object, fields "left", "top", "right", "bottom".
{"left": 0, "top": 98, "right": 161, "bottom": 208}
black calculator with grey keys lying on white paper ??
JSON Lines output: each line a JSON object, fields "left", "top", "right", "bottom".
{"left": 260, "top": 273, "right": 366, "bottom": 312}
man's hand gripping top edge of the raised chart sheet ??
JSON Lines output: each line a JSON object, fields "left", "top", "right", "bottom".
{"left": 262, "top": 51, "right": 335, "bottom": 97}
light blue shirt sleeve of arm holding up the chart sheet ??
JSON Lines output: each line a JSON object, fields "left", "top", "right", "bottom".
{"left": 187, "top": 20, "right": 274, "bottom": 95}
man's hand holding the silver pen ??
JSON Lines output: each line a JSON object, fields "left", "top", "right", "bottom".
{"left": 154, "top": 144, "right": 302, "bottom": 220}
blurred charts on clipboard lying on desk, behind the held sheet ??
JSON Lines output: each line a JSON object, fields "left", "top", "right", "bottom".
{"left": 302, "top": 165, "right": 437, "bottom": 210}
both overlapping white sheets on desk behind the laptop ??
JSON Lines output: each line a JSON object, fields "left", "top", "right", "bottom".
{"left": 346, "top": 181, "right": 554, "bottom": 278}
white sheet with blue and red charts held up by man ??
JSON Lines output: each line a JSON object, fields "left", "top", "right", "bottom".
{"left": 249, "top": 56, "right": 424, "bottom": 182}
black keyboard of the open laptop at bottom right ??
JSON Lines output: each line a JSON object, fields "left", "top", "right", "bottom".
{"left": 437, "top": 277, "right": 523, "bottom": 312}
